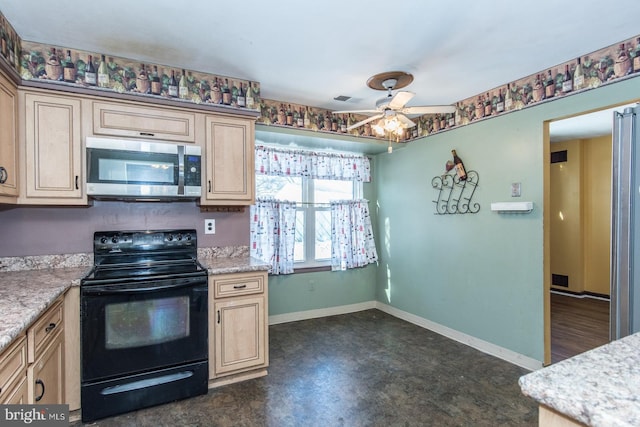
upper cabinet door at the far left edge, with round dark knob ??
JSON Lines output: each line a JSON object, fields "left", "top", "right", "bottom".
{"left": 0, "top": 70, "right": 18, "bottom": 200}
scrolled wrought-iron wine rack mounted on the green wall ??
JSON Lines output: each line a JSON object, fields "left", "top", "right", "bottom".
{"left": 431, "top": 169, "right": 480, "bottom": 215}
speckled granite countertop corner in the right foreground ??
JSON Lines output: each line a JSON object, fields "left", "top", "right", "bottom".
{"left": 519, "top": 333, "right": 640, "bottom": 427}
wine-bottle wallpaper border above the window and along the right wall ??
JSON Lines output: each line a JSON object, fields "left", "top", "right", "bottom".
{"left": 258, "top": 35, "right": 640, "bottom": 141}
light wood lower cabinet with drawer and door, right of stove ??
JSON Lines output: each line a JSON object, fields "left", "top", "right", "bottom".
{"left": 209, "top": 271, "right": 269, "bottom": 387}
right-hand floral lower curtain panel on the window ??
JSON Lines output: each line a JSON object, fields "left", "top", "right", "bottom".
{"left": 331, "top": 200, "right": 378, "bottom": 271}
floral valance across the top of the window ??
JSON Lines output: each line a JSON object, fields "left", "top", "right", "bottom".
{"left": 255, "top": 145, "right": 371, "bottom": 182}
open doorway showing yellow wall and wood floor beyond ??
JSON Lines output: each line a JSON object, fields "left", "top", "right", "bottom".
{"left": 544, "top": 105, "right": 628, "bottom": 365}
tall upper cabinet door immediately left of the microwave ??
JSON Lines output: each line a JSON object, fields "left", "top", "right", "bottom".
{"left": 24, "top": 93, "right": 87, "bottom": 204}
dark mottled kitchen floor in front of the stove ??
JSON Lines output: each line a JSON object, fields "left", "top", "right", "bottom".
{"left": 78, "top": 310, "right": 538, "bottom": 427}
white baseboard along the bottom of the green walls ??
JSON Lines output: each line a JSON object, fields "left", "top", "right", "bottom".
{"left": 269, "top": 301, "right": 542, "bottom": 371}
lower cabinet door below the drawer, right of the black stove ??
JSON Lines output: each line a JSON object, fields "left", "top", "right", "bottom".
{"left": 209, "top": 296, "right": 267, "bottom": 376}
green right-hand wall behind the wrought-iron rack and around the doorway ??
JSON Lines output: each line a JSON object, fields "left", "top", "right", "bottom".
{"left": 375, "top": 78, "right": 640, "bottom": 361}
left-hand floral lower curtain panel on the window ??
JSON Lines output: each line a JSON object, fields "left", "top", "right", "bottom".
{"left": 250, "top": 198, "right": 296, "bottom": 274}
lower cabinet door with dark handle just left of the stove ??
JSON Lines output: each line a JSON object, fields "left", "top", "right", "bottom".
{"left": 27, "top": 331, "right": 65, "bottom": 404}
